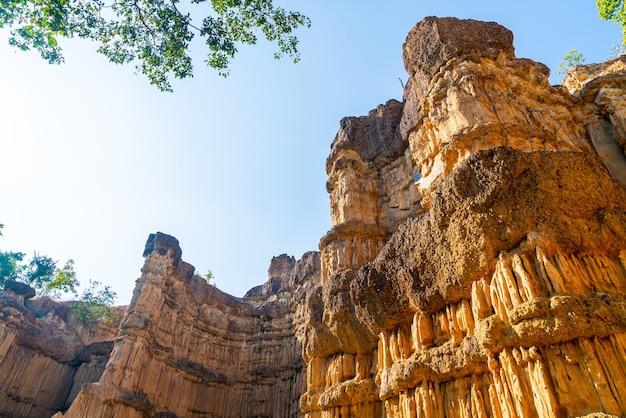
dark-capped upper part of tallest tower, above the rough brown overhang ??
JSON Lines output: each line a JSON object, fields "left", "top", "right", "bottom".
{"left": 401, "top": 17, "right": 589, "bottom": 207}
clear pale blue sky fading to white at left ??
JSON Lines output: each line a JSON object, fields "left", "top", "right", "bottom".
{"left": 0, "top": 0, "right": 621, "bottom": 304}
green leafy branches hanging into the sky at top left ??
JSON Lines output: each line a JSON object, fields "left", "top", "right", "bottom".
{"left": 0, "top": 0, "right": 310, "bottom": 91}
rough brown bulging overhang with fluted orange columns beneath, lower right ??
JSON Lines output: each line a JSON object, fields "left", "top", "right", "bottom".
{"left": 351, "top": 149, "right": 626, "bottom": 418}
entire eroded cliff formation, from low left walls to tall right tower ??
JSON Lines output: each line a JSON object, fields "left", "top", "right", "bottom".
{"left": 0, "top": 17, "right": 626, "bottom": 418}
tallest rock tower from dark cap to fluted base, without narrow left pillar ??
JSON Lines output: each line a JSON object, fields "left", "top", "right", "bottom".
{"left": 350, "top": 18, "right": 626, "bottom": 418}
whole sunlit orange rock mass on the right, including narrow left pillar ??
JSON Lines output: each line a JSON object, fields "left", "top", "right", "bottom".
{"left": 302, "top": 18, "right": 626, "bottom": 418}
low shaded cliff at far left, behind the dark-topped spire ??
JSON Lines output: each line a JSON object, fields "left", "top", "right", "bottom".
{"left": 0, "top": 281, "right": 123, "bottom": 417}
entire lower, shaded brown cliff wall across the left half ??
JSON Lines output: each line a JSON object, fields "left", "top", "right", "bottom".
{"left": 0, "top": 233, "right": 321, "bottom": 418}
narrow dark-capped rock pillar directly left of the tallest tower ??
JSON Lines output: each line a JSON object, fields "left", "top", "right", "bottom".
{"left": 302, "top": 100, "right": 421, "bottom": 418}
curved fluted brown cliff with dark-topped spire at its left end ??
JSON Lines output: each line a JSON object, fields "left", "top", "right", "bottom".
{"left": 64, "top": 233, "right": 319, "bottom": 418}
